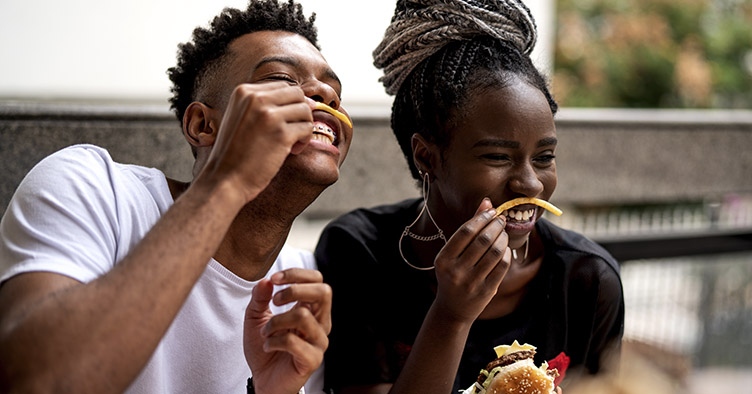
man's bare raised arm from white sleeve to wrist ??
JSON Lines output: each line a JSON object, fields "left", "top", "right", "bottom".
{"left": 0, "top": 177, "right": 247, "bottom": 393}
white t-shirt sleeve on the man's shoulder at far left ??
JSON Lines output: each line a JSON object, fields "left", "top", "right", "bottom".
{"left": 0, "top": 146, "right": 123, "bottom": 282}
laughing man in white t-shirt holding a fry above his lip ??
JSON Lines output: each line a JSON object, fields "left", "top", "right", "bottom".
{"left": 0, "top": 0, "right": 352, "bottom": 393}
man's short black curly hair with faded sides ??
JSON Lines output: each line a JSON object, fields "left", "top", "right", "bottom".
{"left": 167, "top": 0, "right": 320, "bottom": 125}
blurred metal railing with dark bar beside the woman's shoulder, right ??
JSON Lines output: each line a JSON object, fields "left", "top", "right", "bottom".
{"left": 560, "top": 200, "right": 752, "bottom": 368}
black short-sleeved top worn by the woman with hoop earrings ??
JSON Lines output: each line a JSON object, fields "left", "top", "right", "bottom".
{"left": 315, "top": 199, "right": 624, "bottom": 392}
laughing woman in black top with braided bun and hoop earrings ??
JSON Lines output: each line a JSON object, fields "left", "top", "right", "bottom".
{"left": 316, "top": 0, "right": 624, "bottom": 393}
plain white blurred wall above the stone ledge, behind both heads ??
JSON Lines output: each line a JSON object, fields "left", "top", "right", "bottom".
{"left": 0, "top": 0, "right": 555, "bottom": 107}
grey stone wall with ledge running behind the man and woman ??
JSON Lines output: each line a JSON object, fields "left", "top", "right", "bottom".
{"left": 0, "top": 102, "right": 752, "bottom": 219}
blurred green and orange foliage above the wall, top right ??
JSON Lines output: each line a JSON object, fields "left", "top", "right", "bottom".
{"left": 553, "top": 0, "right": 752, "bottom": 108}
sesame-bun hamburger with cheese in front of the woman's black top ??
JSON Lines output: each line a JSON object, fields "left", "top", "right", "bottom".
{"left": 463, "top": 341, "right": 559, "bottom": 394}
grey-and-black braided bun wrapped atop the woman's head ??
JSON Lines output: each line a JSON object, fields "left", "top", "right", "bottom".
{"left": 373, "top": 0, "right": 537, "bottom": 95}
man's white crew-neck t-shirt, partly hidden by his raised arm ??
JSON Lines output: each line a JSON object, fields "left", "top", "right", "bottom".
{"left": 0, "top": 145, "right": 323, "bottom": 393}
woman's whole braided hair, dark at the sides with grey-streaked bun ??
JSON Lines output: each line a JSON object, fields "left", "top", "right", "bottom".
{"left": 373, "top": 0, "right": 558, "bottom": 180}
